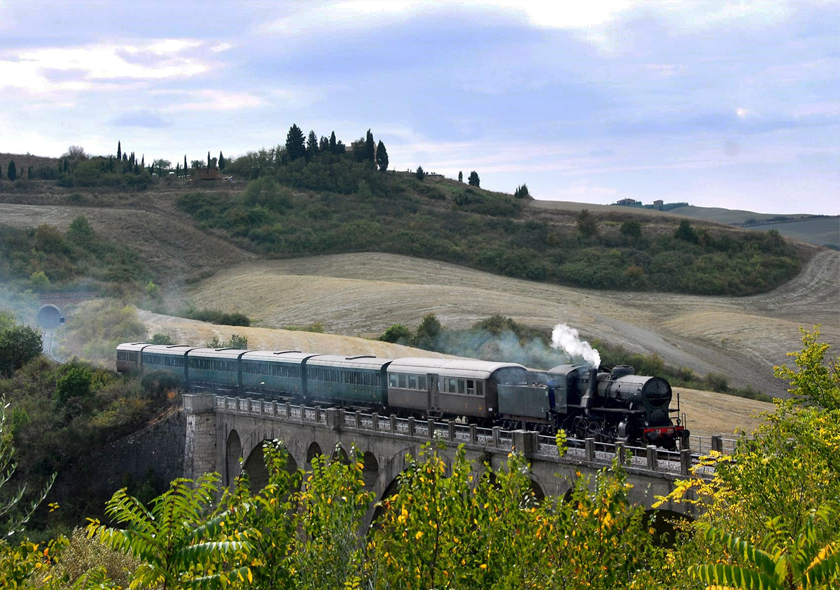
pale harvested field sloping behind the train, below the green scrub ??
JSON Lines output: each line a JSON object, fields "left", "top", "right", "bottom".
{"left": 189, "top": 251, "right": 840, "bottom": 395}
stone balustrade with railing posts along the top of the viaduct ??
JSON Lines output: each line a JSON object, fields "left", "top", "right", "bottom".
{"left": 207, "top": 395, "right": 714, "bottom": 480}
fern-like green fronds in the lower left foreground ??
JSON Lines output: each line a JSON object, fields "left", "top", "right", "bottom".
{"left": 88, "top": 474, "right": 252, "bottom": 589}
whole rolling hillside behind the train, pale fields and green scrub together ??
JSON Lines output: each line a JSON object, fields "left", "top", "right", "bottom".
{"left": 0, "top": 151, "right": 840, "bottom": 408}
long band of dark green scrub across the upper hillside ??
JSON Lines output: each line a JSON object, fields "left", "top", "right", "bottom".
{"left": 174, "top": 150, "right": 800, "bottom": 295}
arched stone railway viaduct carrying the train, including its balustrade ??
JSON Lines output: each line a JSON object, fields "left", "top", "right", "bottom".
{"left": 184, "top": 393, "right": 708, "bottom": 519}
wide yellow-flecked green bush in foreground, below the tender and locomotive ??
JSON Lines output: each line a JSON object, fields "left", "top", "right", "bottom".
{"left": 368, "top": 445, "right": 655, "bottom": 589}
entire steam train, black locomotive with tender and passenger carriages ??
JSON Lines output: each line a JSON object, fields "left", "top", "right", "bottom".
{"left": 117, "top": 343, "right": 689, "bottom": 449}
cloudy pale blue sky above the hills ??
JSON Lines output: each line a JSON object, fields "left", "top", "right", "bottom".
{"left": 0, "top": 0, "right": 840, "bottom": 215}
